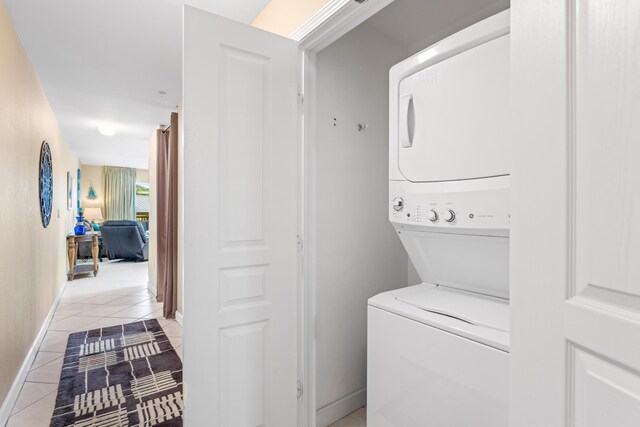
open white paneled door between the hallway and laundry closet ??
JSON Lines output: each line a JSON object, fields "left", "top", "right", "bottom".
{"left": 183, "top": 7, "right": 297, "bottom": 427}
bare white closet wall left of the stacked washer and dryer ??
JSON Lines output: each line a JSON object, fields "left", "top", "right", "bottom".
{"left": 315, "top": 24, "right": 408, "bottom": 425}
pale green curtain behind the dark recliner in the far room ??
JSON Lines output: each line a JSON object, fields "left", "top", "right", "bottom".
{"left": 104, "top": 166, "right": 136, "bottom": 220}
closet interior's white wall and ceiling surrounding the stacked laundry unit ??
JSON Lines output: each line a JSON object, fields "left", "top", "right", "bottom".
{"left": 304, "top": 0, "right": 509, "bottom": 427}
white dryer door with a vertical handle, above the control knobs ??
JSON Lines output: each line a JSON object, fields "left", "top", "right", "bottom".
{"left": 397, "top": 34, "right": 510, "bottom": 182}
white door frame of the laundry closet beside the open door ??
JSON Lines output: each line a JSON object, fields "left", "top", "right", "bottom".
{"left": 290, "top": 0, "right": 394, "bottom": 427}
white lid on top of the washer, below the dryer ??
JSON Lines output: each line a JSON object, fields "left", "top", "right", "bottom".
{"left": 396, "top": 286, "right": 509, "bottom": 333}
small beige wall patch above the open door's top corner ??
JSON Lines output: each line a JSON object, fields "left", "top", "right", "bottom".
{"left": 251, "top": 0, "right": 329, "bottom": 37}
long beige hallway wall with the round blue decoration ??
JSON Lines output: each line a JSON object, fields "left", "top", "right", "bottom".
{"left": 0, "top": 2, "right": 79, "bottom": 401}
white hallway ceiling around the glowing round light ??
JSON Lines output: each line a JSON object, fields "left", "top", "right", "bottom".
{"left": 4, "top": 0, "right": 268, "bottom": 169}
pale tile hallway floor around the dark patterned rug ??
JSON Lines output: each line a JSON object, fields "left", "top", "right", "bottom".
{"left": 7, "top": 260, "right": 182, "bottom": 427}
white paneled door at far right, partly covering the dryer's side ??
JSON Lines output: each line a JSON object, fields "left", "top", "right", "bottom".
{"left": 510, "top": 0, "right": 640, "bottom": 427}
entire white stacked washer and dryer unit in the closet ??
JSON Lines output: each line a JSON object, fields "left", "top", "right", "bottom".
{"left": 367, "top": 11, "right": 510, "bottom": 427}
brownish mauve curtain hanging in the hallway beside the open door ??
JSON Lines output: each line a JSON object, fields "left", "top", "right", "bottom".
{"left": 156, "top": 113, "right": 178, "bottom": 318}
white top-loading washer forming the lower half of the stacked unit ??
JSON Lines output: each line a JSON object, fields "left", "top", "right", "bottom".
{"left": 367, "top": 284, "right": 509, "bottom": 427}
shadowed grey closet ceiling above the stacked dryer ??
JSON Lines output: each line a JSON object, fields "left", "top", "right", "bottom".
{"left": 367, "top": 0, "right": 509, "bottom": 54}
